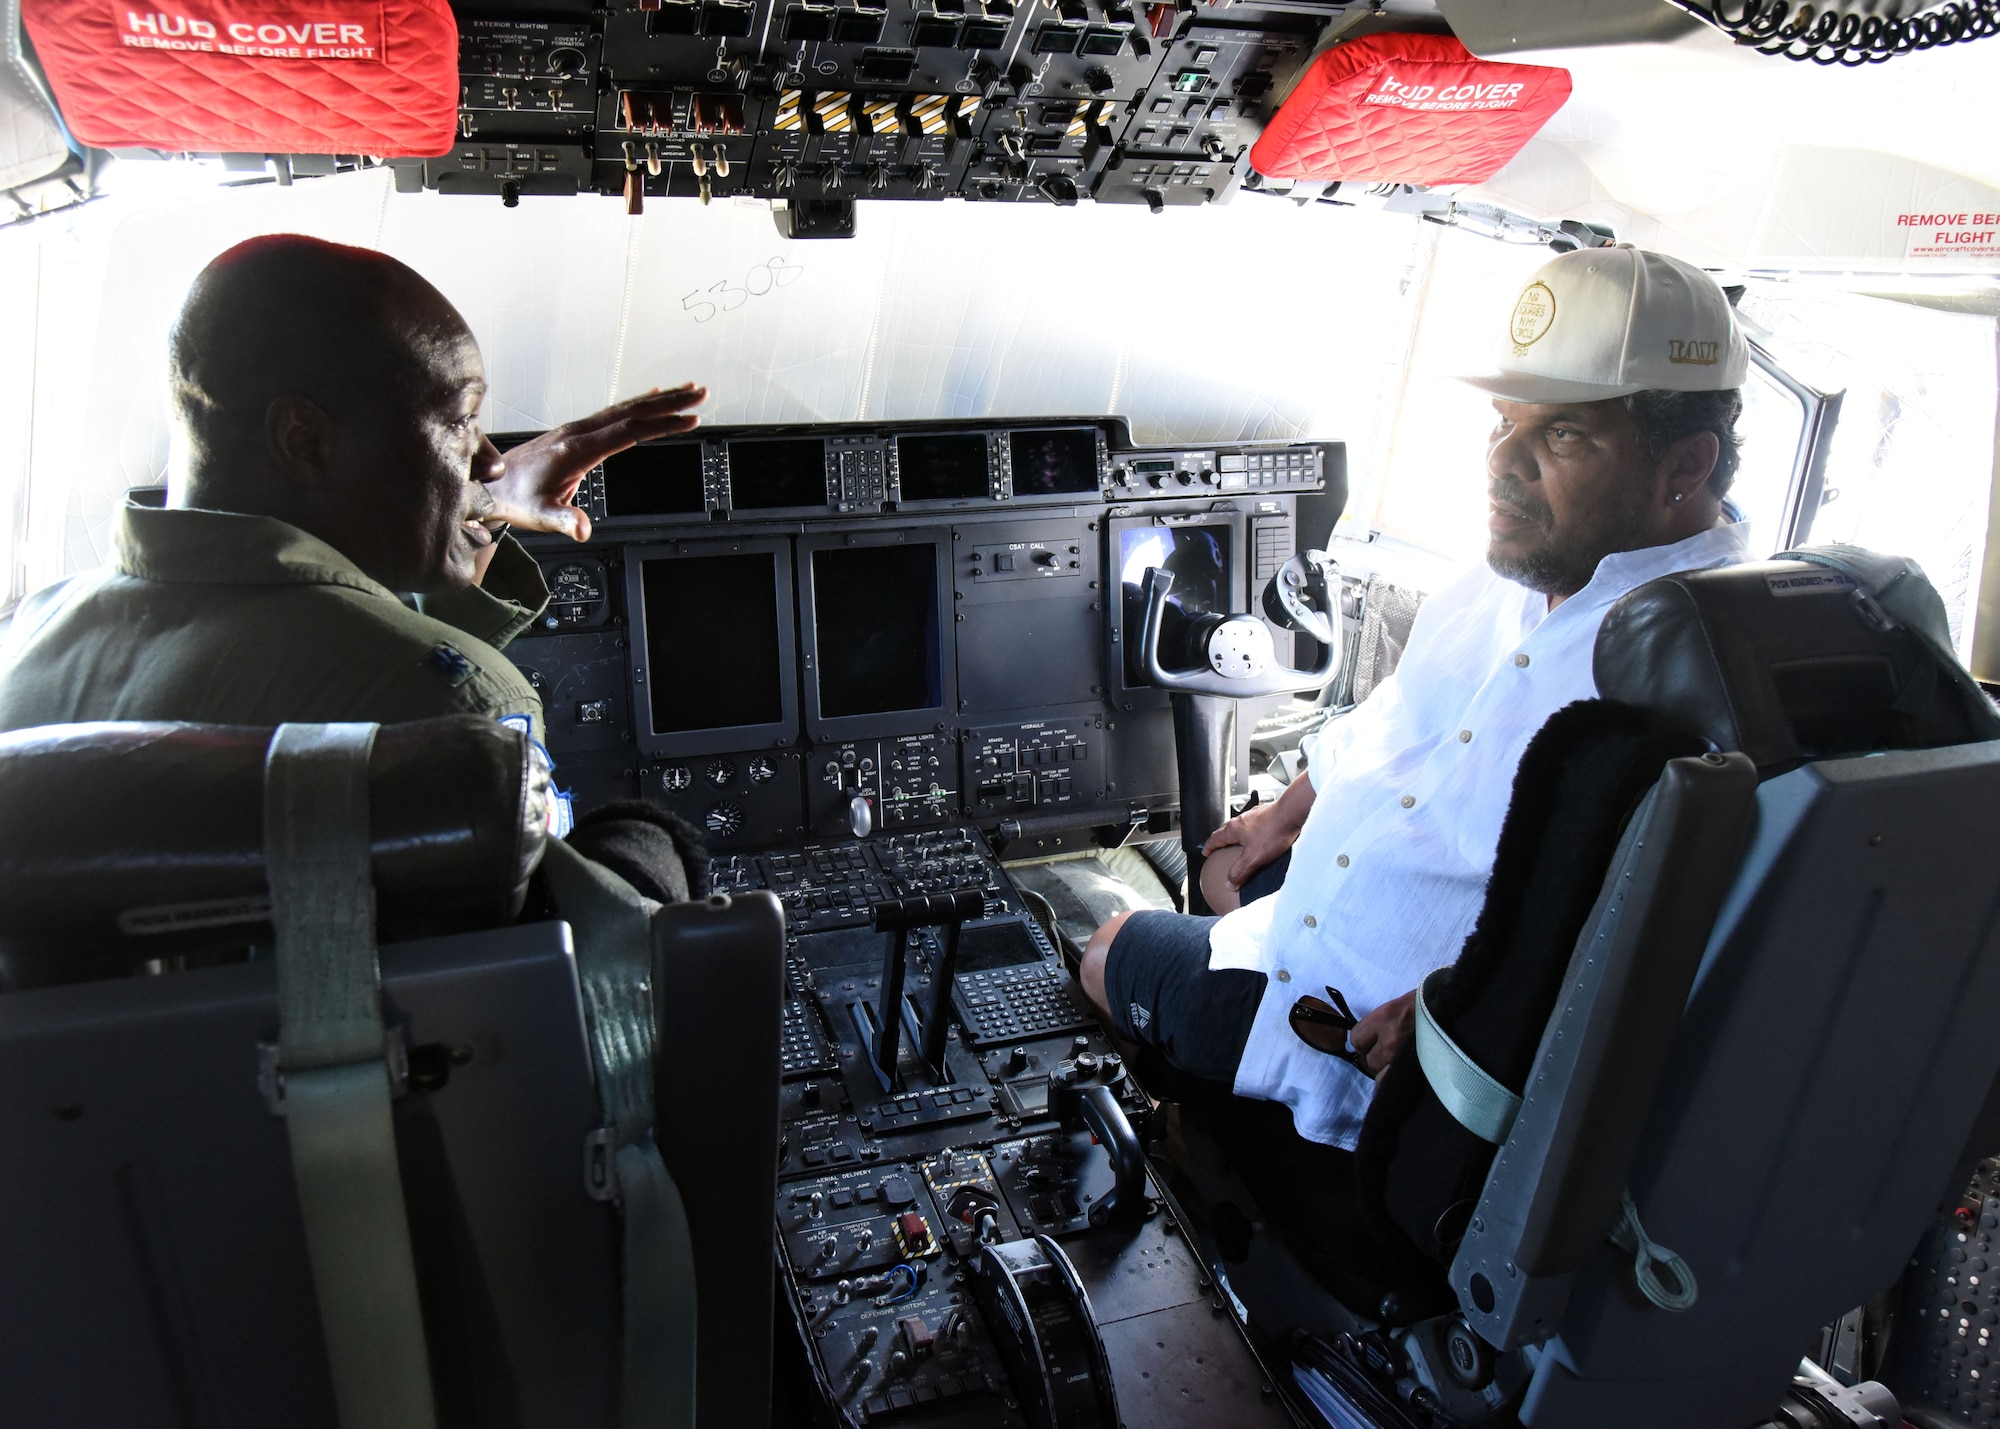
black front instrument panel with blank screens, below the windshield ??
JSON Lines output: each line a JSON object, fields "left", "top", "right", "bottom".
{"left": 508, "top": 406, "right": 1346, "bottom": 849}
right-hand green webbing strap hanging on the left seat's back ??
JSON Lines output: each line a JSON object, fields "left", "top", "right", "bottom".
{"left": 542, "top": 839, "right": 696, "bottom": 1429}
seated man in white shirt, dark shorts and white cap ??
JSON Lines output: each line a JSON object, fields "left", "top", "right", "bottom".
{"left": 1082, "top": 246, "right": 1750, "bottom": 1224}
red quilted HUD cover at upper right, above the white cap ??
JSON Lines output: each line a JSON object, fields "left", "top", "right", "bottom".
{"left": 1250, "top": 34, "right": 1570, "bottom": 186}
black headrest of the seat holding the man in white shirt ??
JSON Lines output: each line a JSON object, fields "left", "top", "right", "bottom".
{"left": 1594, "top": 546, "right": 2000, "bottom": 777}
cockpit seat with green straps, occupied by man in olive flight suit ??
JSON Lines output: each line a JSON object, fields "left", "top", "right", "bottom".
{"left": 0, "top": 717, "right": 784, "bottom": 1429}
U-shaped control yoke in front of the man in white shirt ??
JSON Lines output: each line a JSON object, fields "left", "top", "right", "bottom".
{"left": 1138, "top": 550, "right": 1340, "bottom": 700}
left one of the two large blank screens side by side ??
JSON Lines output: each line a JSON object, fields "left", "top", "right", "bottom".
{"left": 640, "top": 550, "right": 792, "bottom": 735}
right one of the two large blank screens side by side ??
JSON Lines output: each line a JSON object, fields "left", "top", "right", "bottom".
{"left": 812, "top": 540, "right": 944, "bottom": 719}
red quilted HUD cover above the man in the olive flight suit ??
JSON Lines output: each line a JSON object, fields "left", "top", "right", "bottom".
{"left": 22, "top": 0, "right": 458, "bottom": 158}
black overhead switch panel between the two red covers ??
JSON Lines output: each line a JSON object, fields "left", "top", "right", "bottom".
{"left": 392, "top": 0, "right": 1360, "bottom": 210}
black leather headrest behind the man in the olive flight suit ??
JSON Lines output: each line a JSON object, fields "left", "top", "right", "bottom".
{"left": 0, "top": 715, "right": 548, "bottom": 989}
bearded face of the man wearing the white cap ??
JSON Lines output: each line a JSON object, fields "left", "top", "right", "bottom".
{"left": 1486, "top": 398, "right": 1666, "bottom": 598}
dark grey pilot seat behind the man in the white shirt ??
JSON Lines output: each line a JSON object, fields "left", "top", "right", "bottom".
{"left": 1142, "top": 548, "right": 2000, "bottom": 1429}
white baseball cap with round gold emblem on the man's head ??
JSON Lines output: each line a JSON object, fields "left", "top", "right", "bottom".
{"left": 1460, "top": 244, "right": 1750, "bottom": 402}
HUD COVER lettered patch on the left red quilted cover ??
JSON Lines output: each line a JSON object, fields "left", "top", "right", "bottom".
{"left": 112, "top": 0, "right": 384, "bottom": 62}
